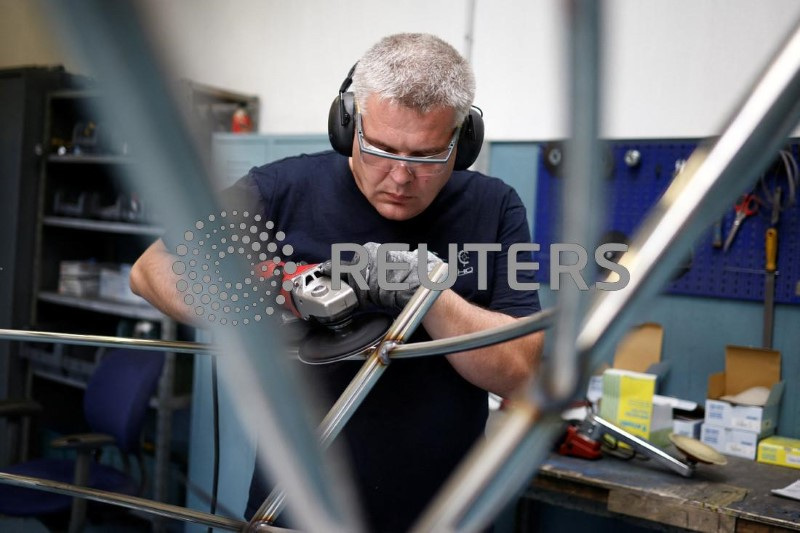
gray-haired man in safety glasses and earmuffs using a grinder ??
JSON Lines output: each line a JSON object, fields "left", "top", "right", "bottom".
{"left": 131, "top": 34, "right": 542, "bottom": 531}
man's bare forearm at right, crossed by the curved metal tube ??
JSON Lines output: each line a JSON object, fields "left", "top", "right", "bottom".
{"left": 423, "top": 290, "right": 544, "bottom": 397}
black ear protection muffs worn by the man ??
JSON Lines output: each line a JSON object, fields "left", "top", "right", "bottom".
{"left": 328, "top": 63, "right": 483, "bottom": 170}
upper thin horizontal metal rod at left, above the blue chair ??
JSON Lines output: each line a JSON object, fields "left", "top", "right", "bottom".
{"left": 0, "top": 329, "right": 214, "bottom": 353}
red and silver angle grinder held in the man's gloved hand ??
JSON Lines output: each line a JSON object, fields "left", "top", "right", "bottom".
{"left": 258, "top": 261, "right": 392, "bottom": 365}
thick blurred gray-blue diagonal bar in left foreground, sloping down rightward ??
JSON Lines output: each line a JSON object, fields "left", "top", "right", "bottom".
{"left": 46, "top": 0, "right": 362, "bottom": 533}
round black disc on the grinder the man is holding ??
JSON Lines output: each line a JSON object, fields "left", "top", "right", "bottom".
{"left": 298, "top": 313, "right": 392, "bottom": 365}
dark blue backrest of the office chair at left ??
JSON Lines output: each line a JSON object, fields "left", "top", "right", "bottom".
{"left": 83, "top": 348, "right": 164, "bottom": 454}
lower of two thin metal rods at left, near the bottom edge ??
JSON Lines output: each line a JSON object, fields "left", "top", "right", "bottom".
{"left": 0, "top": 472, "right": 250, "bottom": 533}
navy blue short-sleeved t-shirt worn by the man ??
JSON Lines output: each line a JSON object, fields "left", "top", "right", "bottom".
{"left": 238, "top": 152, "right": 539, "bottom": 531}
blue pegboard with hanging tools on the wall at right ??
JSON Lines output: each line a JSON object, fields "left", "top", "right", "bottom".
{"left": 534, "top": 141, "right": 800, "bottom": 304}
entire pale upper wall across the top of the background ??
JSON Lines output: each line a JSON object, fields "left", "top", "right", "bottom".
{"left": 0, "top": 0, "right": 800, "bottom": 140}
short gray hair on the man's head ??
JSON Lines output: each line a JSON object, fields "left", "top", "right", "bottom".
{"left": 353, "top": 33, "right": 475, "bottom": 124}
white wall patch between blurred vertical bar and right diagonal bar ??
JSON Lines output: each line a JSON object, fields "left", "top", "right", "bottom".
{"left": 604, "top": 0, "right": 800, "bottom": 138}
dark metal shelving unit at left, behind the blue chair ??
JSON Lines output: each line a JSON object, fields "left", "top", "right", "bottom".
{"left": 20, "top": 85, "right": 190, "bottom": 510}
